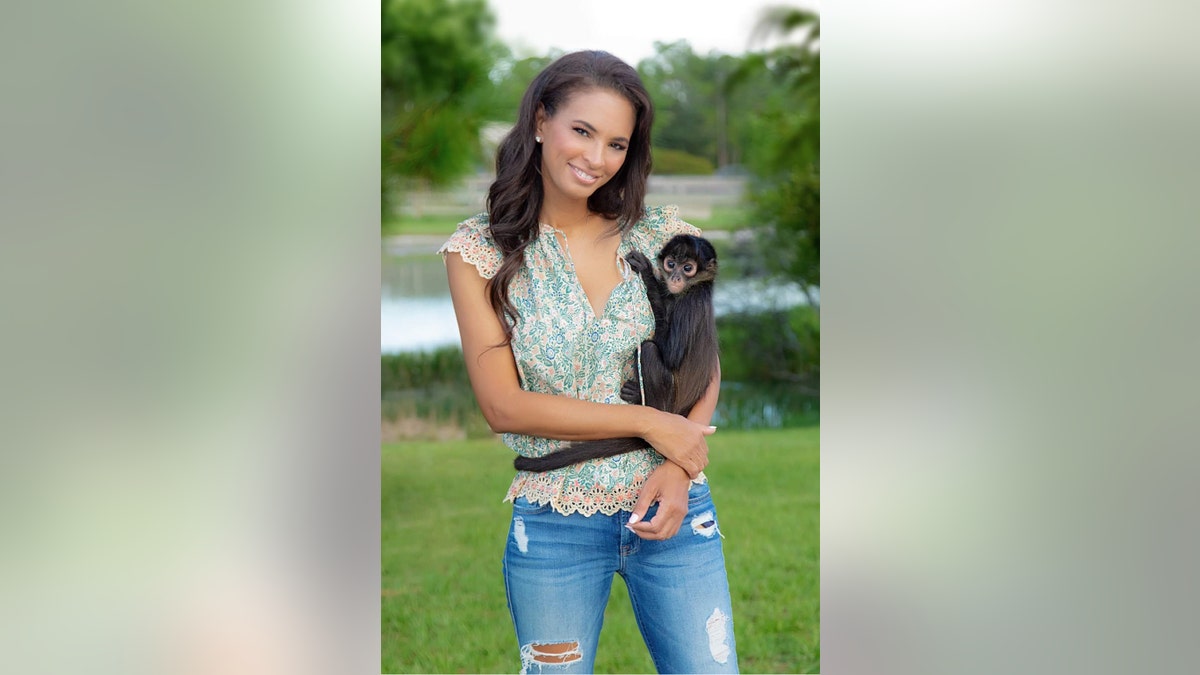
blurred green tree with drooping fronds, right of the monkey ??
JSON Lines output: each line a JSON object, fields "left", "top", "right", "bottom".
{"left": 731, "top": 7, "right": 821, "bottom": 297}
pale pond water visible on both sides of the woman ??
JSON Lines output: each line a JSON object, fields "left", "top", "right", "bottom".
{"left": 379, "top": 246, "right": 808, "bottom": 353}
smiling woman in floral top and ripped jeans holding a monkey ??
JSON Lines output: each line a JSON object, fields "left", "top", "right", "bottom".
{"left": 442, "top": 52, "right": 737, "bottom": 673}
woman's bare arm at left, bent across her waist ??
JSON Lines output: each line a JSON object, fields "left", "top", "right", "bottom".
{"left": 446, "top": 253, "right": 715, "bottom": 476}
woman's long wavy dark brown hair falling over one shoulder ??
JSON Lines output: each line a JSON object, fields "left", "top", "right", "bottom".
{"left": 487, "top": 52, "right": 654, "bottom": 344}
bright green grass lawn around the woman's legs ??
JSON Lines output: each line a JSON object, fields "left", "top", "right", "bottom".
{"left": 382, "top": 426, "right": 821, "bottom": 673}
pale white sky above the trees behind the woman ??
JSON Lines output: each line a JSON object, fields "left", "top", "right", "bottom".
{"left": 488, "top": 0, "right": 820, "bottom": 66}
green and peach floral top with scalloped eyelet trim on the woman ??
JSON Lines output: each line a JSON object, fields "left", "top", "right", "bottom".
{"left": 438, "top": 201, "right": 703, "bottom": 515}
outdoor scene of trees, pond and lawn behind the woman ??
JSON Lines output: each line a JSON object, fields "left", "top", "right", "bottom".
{"left": 380, "top": 0, "right": 821, "bottom": 673}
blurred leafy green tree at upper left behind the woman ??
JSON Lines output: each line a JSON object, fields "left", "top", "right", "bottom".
{"left": 380, "top": 0, "right": 506, "bottom": 219}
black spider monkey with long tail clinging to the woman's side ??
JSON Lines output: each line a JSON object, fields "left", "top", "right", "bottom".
{"left": 512, "top": 234, "right": 718, "bottom": 472}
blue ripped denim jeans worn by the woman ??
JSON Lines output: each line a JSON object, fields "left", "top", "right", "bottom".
{"left": 504, "top": 484, "right": 738, "bottom": 675}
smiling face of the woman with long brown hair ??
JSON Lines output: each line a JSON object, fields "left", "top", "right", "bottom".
{"left": 538, "top": 89, "right": 635, "bottom": 206}
